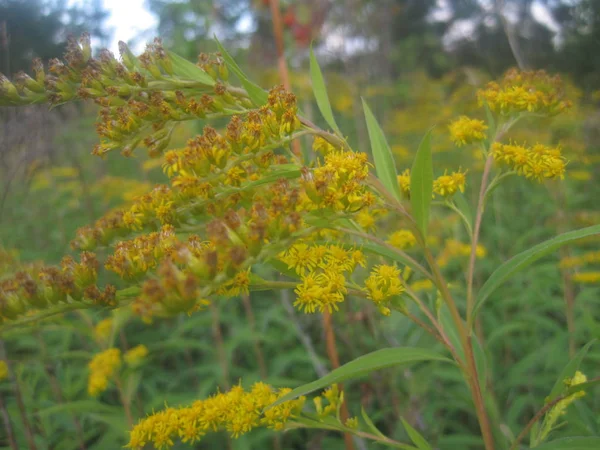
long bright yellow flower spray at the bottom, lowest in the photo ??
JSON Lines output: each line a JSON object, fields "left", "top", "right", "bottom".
{"left": 127, "top": 382, "right": 305, "bottom": 450}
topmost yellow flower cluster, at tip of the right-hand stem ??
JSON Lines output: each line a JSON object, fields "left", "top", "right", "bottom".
{"left": 477, "top": 69, "right": 571, "bottom": 116}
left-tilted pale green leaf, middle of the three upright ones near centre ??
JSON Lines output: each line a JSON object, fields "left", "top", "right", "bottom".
{"left": 362, "top": 99, "right": 400, "bottom": 201}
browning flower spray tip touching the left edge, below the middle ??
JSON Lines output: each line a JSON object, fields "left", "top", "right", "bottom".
{"left": 0, "top": 252, "right": 115, "bottom": 322}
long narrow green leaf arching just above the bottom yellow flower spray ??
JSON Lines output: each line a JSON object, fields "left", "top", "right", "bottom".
{"left": 272, "top": 347, "right": 452, "bottom": 406}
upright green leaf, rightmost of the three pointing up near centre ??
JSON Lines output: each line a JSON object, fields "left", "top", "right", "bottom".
{"left": 410, "top": 130, "right": 433, "bottom": 237}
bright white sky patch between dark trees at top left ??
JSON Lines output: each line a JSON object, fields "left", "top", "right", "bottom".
{"left": 69, "top": 0, "right": 158, "bottom": 56}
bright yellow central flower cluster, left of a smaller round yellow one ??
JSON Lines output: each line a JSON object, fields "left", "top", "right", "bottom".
{"left": 279, "top": 242, "right": 365, "bottom": 313}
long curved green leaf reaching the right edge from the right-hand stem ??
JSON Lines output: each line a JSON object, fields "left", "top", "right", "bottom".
{"left": 474, "top": 224, "right": 600, "bottom": 317}
